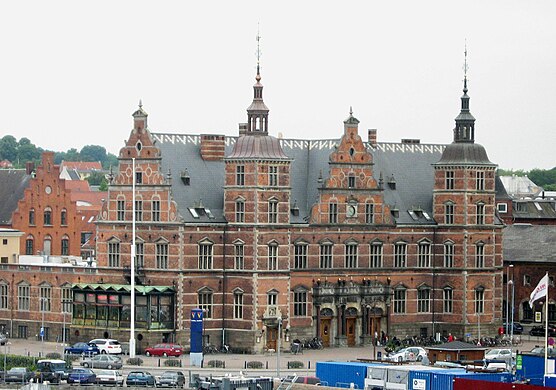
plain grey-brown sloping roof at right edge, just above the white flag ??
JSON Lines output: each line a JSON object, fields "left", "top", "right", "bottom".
{"left": 503, "top": 224, "right": 556, "bottom": 263}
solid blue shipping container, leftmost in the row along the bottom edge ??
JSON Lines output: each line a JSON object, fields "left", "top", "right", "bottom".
{"left": 316, "top": 362, "right": 384, "bottom": 389}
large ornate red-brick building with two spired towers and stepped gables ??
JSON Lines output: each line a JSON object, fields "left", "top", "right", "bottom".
{"left": 0, "top": 63, "right": 503, "bottom": 351}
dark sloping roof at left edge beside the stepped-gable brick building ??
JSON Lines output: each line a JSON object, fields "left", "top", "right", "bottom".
{"left": 0, "top": 169, "right": 31, "bottom": 225}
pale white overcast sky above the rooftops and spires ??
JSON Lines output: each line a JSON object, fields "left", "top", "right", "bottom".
{"left": 0, "top": 0, "right": 556, "bottom": 170}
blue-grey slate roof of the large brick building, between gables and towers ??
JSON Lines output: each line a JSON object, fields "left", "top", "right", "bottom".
{"left": 151, "top": 133, "right": 452, "bottom": 224}
